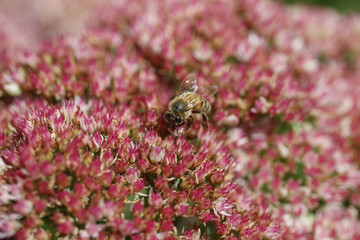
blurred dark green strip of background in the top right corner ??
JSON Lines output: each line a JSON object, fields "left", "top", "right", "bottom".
{"left": 281, "top": 0, "right": 360, "bottom": 13}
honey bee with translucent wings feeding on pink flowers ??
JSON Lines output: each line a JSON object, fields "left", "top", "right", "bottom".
{"left": 165, "top": 73, "right": 218, "bottom": 131}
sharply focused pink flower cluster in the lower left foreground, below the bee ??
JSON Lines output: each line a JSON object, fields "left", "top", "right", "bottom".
{"left": 0, "top": 100, "right": 277, "bottom": 239}
